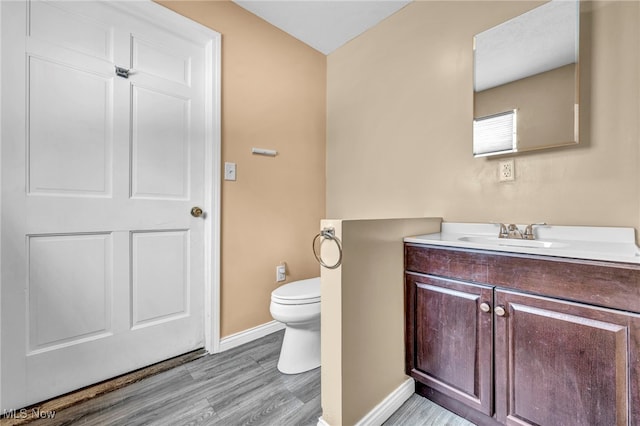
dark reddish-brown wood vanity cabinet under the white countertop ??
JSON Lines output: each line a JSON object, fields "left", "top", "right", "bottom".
{"left": 405, "top": 244, "right": 640, "bottom": 426}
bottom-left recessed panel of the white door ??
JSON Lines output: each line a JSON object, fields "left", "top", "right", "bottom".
{"left": 27, "top": 234, "right": 112, "bottom": 354}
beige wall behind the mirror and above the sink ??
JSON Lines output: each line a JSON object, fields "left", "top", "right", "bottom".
{"left": 327, "top": 1, "right": 640, "bottom": 233}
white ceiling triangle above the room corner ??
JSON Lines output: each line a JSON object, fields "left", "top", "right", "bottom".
{"left": 233, "top": 0, "right": 412, "bottom": 55}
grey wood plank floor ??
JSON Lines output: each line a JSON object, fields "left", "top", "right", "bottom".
{"left": 20, "top": 331, "right": 472, "bottom": 426}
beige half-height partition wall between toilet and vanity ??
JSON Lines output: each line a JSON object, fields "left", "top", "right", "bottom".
{"left": 321, "top": 218, "right": 441, "bottom": 426}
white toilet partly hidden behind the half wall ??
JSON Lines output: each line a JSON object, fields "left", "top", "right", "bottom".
{"left": 269, "top": 277, "right": 320, "bottom": 374}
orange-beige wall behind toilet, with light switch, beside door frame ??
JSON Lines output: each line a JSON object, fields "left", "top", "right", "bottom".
{"left": 159, "top": 1, "right": 326, "bottom": 337}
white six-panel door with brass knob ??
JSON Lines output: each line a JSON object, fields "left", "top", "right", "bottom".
{"left": 0, "top": 1, "right": 219, "bottom": 409}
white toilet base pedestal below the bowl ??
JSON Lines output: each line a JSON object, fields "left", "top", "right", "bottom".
{"left": 278, "top": 321, "right": 320, "bottom": 374}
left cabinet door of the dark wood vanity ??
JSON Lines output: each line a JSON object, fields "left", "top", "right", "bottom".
{"left": 405, "top": 274, "right": 493, "bottom": 415}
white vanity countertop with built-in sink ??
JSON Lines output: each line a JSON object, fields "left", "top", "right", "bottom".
{"left": 404, "top": 222, "right": 640, "bottom": 264}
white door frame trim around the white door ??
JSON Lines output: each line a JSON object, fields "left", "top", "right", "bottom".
{"left": 0, "top": 0, "right": 221, "bottom": 406}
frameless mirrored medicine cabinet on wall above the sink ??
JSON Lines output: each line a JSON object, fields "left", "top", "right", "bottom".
{"left": 473, "top": 0, "right": 580, "bottom": 157}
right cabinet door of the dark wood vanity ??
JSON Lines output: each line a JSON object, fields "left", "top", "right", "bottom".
{"left": 495, "top": 290, "right": 640, "bottom": 426}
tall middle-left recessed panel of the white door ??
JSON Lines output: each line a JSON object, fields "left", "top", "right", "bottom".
{"left": 27, "top": 57, "right": 114, "bottom": 196}
